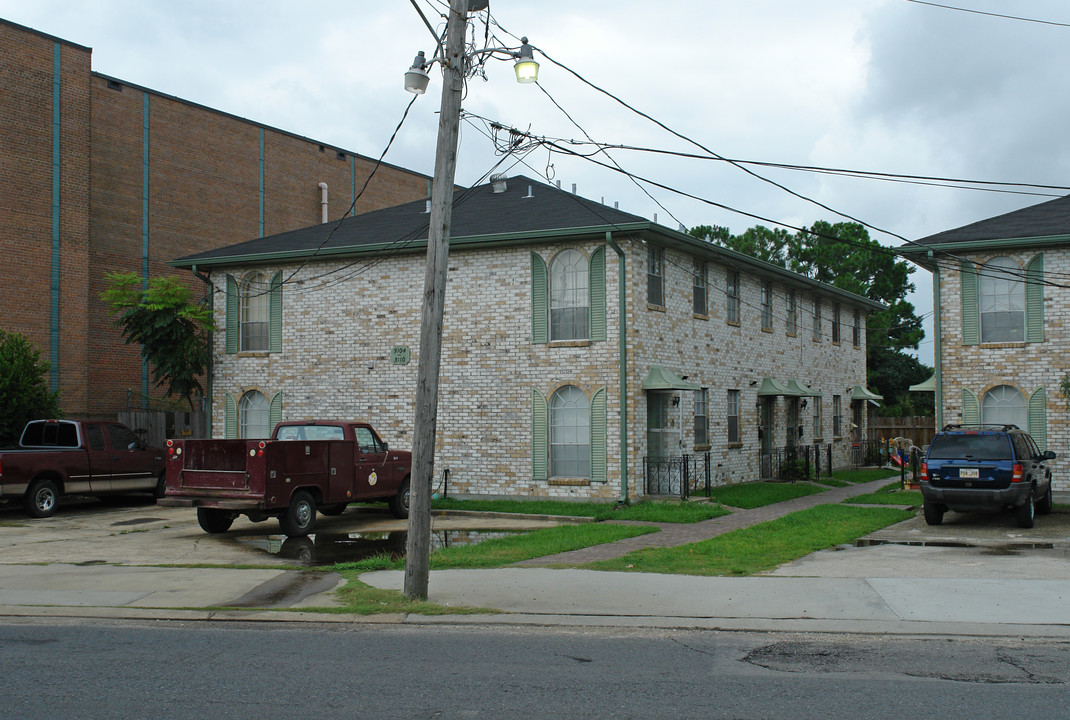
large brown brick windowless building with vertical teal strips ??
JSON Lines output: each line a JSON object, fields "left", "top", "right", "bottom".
{"left": 0, "top": 19, "right": 429, "bottom": 416}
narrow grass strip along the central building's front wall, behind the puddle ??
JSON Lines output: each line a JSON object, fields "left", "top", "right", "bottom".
{"left": 431, "top": 497, "right": 729, "bottom": 522}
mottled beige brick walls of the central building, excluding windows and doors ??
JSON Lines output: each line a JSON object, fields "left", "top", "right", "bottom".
{"left": 212, "top": 233, "right": 866, "bottom": 501}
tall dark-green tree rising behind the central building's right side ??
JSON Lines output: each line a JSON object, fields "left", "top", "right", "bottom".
{"left": 691, "top": 220, "right": 933, "bottom": 414}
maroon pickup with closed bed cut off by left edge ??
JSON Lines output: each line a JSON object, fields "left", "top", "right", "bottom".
{"left": 0, "top": 420, "right": 164, "bottom": 518}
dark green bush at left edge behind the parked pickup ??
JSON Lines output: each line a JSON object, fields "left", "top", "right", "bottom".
{"left": 0, "top": 330, "right": 63, "bottom": 446}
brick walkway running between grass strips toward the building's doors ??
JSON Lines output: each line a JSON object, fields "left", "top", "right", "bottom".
{"left": 514, "top": 477, "right": 891, "bottom": 567}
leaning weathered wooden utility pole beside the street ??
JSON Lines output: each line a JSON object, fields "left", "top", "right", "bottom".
{"left": 404, "top": 0, "right": 469, "bottom": 600}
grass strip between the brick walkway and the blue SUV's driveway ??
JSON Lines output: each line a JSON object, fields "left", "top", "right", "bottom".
{"left": 584, "top": 505, "right": 914, "bottom": 576}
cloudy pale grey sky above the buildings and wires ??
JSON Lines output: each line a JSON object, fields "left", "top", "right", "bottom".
{"left": 0, "top": 0, "right": 1070, "bottom": 363}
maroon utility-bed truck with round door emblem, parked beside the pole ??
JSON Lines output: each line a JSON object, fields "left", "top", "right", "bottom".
{"left": 158, "top": 420, "right": 412, "bottom": 537}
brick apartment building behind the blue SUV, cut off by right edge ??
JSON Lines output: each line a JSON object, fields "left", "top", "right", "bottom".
{"left": 900, "top": 196, "right": 1070, "bottom": 492}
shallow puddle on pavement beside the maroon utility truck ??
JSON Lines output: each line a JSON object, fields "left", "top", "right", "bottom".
{"left": 233, "top": 530, "right": 517, "bottom": 565}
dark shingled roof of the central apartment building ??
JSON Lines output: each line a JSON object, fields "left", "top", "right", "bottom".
{"left": 169, "top": 175, "right": 651, "bottom": 267}
